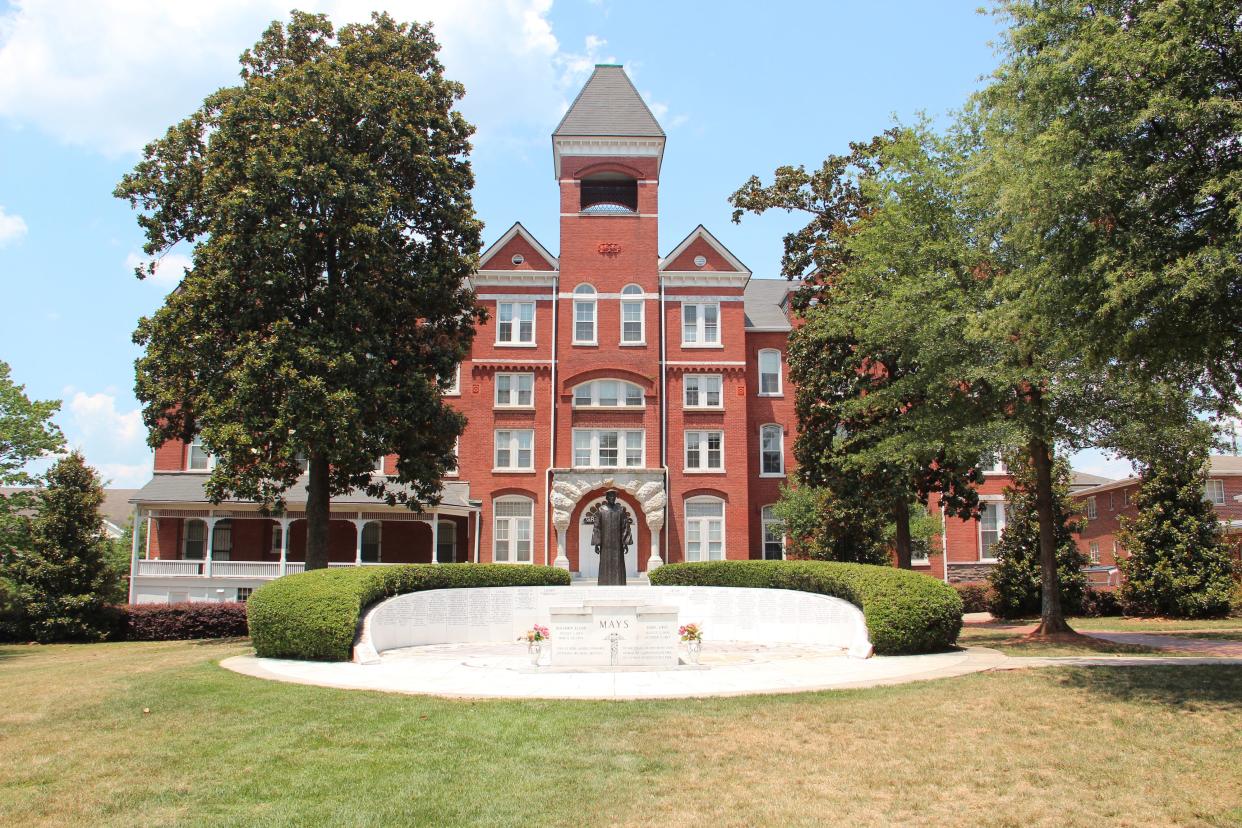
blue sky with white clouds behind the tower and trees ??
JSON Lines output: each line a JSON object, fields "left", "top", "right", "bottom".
{"left": 0, "top": 0, "right": 1142, "bottom": 485}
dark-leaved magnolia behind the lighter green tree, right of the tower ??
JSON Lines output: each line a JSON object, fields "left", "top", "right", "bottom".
{"left": 729, "top": 129, "right": 981, "bottom": 569}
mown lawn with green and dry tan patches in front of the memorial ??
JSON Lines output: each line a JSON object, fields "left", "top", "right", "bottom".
{"left": 0, "top": 643, "right": 1242, "bottom": 827}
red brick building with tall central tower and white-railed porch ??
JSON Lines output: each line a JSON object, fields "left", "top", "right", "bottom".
{"left": 121, "top": 66, "right": 1083, "bottom": 601}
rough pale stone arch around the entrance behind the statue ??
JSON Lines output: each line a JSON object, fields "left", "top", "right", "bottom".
{"left": 551, "top": 469, "right": 668, "bottom": 571}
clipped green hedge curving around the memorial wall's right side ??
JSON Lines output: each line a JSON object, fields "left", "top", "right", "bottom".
{"left": 651, "top": 561, "right": 961, "bottom": 655}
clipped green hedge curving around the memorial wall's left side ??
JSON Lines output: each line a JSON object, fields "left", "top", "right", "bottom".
{"left": 246, "top": 564, "right": 569, "bottom": 662}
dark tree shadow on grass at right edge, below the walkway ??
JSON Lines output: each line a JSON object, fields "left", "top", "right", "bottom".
{"left": 1056, "top": 664, "right": 1242, "bottom": 713}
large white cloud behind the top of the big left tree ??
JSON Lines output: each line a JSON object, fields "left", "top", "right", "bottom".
{"left": 0, "top": 0, "right": 586, "bottom": 154}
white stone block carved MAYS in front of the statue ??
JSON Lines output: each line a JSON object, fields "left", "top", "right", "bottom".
{"left": 548, "top": 598, "right": 678, "bottom": 667}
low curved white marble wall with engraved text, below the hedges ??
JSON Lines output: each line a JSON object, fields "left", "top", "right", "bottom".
{"left": 354, "top": 586, "right": 872, "bottom": 664}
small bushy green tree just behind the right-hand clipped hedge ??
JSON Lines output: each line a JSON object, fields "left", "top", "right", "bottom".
{"left": 775, "top": 484, "right": 889, "bottom": 565}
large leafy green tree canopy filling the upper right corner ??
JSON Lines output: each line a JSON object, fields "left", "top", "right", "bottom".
{"left": 975, "top": 0, "right": 1242, "bottom": 402}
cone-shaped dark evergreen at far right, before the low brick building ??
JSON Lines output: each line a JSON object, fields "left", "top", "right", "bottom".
{"left": 1118, "top": 451, "right": 1233, "bottom": 618}
